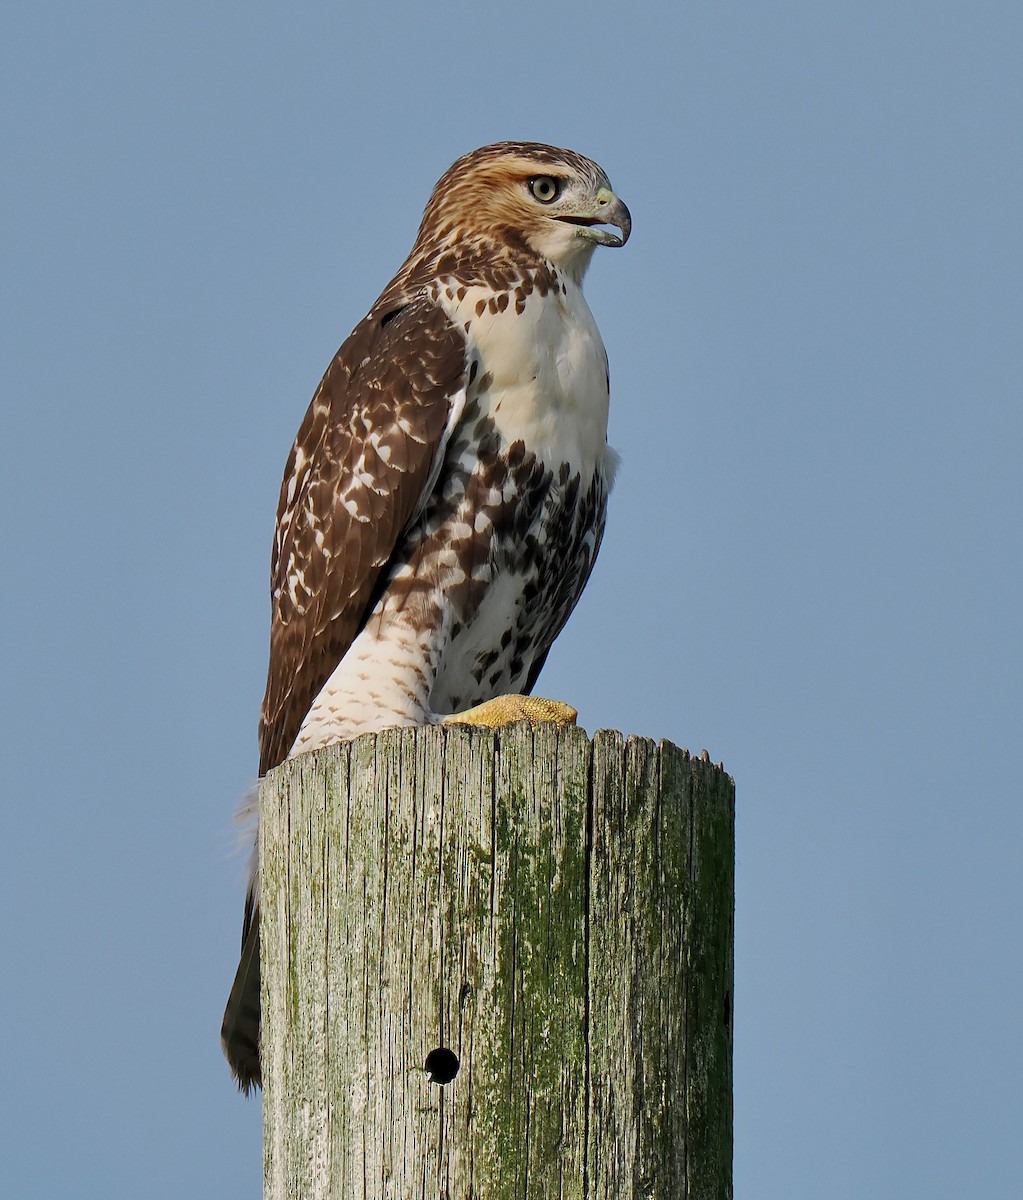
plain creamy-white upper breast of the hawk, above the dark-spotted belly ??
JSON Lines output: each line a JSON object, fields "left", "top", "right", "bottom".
{"left": 438, "top": 280, "right": 608, "bottom": 484}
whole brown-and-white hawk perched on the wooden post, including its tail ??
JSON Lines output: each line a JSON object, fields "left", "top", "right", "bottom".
{"left": 222, "top": 142, "right": 632, "bottom": 1091}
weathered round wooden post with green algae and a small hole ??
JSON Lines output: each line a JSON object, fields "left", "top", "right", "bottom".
{"left": 259, "top": 725, "right": 735, "bottom": 1200}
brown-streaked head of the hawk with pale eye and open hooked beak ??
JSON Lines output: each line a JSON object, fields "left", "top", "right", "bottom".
{"left": 411, "top": 142, "right": 632, "bottom": 278}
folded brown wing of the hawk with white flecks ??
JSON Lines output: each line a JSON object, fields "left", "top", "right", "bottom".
{"left": 259, "top": 294, "right": 465, "bottom": 775}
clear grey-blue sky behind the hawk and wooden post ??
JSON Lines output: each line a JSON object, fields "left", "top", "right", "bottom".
{"left": 0, "top": 0, "right": 1023, "bottom": 1200}
